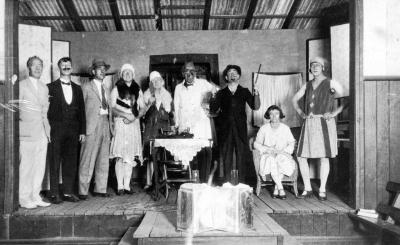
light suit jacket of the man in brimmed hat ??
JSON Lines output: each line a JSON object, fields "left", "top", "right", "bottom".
{"left": 81, "top": 80, "right": 111, "bottom": 135}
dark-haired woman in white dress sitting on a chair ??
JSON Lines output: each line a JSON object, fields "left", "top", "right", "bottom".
{"left": 254, "top": 105, "right": 296, "bottom": 199}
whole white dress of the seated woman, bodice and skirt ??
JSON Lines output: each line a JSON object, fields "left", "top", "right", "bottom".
{"left": 254, "top": 122, "right": 296, "bottom": 179}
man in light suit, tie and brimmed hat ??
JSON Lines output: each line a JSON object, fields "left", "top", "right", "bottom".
{"left": 79, "top": 59, "right": 111, "bottom": 200}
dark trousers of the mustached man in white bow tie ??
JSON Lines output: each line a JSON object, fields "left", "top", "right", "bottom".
{"left": 50, "top": 123, "right": 79, "bottom": 195}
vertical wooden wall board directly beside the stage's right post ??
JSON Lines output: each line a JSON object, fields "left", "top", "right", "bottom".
{"left": 364, "top": 81, "right": 377, "bottom": 208}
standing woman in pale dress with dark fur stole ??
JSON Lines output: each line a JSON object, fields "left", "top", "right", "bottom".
{"left": 110, "top": 64, "right": 144, "bottom": 195}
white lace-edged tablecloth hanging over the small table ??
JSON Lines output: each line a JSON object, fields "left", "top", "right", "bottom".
{"left": 154, "top": 138, "right": 212, "bottom": 166}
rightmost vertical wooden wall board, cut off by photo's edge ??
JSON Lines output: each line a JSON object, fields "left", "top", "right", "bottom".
{"left": 388, "top": 81, "right": 400, "bottom": 183}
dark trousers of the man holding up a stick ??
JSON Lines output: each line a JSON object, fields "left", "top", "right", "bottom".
{"left": 220, "top": 127, "right": 247, "bottom": 183}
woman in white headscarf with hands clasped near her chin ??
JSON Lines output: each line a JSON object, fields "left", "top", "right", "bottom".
{"left": 143, "top": 71, "right": 174, "bottom": 190}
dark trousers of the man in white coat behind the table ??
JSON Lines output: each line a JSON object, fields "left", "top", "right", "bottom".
{"left": 190, "top": 147, "right": 212, "bottom": 183}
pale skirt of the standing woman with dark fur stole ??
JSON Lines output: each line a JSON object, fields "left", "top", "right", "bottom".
{"left": 110, "top": 117, "right": 143, "bottom": 167}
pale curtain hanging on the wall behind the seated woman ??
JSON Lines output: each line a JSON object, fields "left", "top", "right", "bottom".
{"left": 253, "top": 73, "right": 302, "bottom": 128}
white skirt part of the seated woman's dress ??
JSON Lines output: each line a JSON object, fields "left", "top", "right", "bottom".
{"left": 259, "top": 154, "right": 296, "bottom": 180}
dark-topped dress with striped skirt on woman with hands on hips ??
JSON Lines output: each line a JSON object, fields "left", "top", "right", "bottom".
{"left": 297, "top": 79, "right": 338, "bottom": 158}
